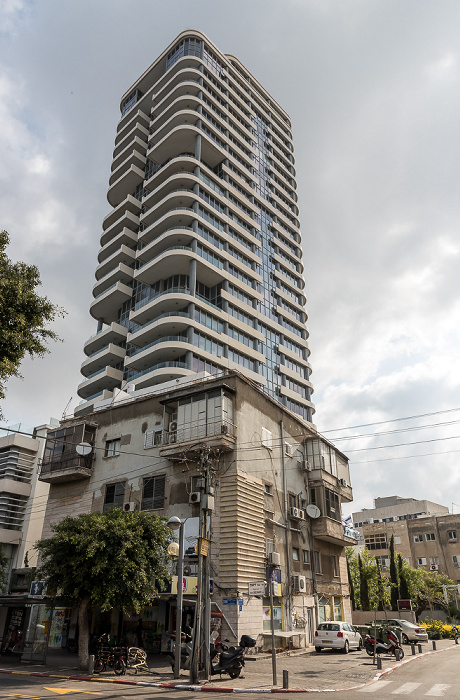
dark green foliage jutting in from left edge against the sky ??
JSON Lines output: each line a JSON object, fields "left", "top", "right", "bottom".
{"left": 0, "top": 231, "right": 65, "bottom": 418}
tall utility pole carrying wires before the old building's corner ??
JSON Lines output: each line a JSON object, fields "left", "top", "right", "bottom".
{"left": 190, "top": 445, "right": 214, "bottom": 683}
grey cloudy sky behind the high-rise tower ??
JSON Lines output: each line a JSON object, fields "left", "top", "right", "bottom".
{"left": 0, "top": 0, "right": 460, "bottom": 513}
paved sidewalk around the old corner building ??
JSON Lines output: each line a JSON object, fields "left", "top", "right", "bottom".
{"left": 0, "top": 639, "right": 460, "bottom": 692}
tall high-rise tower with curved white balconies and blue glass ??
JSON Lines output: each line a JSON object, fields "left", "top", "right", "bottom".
{"left": 78, "top": 31, "right": 313, "bottom": 421}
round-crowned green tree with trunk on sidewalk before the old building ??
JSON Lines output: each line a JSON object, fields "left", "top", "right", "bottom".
{"left": 35, "top": 508, "right": 174, "bottom": 670}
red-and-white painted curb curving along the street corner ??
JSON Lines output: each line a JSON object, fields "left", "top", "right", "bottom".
{"left": 0, "top": 645, "right": 456, "bottom": 694}
